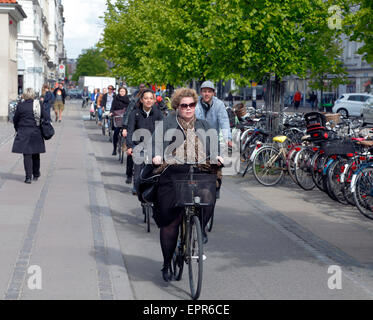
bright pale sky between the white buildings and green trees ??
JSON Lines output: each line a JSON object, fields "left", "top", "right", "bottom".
{"left": 62, "top": 0, "right": 106, "bottom": 59}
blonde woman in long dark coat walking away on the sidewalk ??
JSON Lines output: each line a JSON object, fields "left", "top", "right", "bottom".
{"left": 12, "top": 88, "right": 50, "bottom": 183}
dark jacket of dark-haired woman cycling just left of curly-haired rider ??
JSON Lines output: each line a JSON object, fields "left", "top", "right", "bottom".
{"left": 126, "top": 106, "right": 163, "bottom": 148}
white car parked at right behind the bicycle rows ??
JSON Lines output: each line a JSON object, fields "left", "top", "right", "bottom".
{"left": 332, "top": 93, "right": 373, "bottom": 117}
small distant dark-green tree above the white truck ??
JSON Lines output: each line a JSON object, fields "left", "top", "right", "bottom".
{"left": 72, "top": 48, "right": 108, "bottom": 81}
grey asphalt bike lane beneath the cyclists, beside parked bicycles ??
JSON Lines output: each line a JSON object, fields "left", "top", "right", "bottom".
{"left": 85, "top": 108, "right": 373, "bottom": 300}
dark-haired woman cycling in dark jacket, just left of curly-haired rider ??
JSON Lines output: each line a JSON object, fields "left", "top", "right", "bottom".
{"left": 126, "top": 89, "right": 163, "bottom": 194}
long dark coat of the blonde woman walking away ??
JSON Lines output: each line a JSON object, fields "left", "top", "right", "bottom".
{"left": 12, "top": 100, "right": 50, "bottom": 154}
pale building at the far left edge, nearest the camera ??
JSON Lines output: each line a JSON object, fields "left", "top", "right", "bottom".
{"left": 0, "top": 0, "right": 26, "bottom": 120}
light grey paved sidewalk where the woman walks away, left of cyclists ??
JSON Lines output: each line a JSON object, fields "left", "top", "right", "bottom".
{"left": 0, "top": 103, "right": 132, "bottom": 299}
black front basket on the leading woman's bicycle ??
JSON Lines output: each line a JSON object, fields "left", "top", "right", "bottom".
{"left": 173, "top": 173, "right": 216, "bottom": 207}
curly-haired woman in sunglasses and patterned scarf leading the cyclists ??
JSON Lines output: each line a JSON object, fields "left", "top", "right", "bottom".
{"left": 153, "top": 88, "right": 223, "bottom": 282}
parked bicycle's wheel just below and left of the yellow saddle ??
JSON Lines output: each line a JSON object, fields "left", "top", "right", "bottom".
{"left": 253, "top": 146, "right": 285, "bottom": 186}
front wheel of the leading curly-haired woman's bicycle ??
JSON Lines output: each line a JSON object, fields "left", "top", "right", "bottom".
{"left": 187, "top": 216, "right": 203, "bottom": 300}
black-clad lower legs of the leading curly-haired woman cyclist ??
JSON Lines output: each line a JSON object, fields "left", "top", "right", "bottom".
{"left": 159, "top": 206, "right": 215, "bottom": 265}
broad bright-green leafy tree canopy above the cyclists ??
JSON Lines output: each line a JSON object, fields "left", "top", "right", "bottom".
{"left": 99, "top": 0, "right": 348, "bottom": 94}
